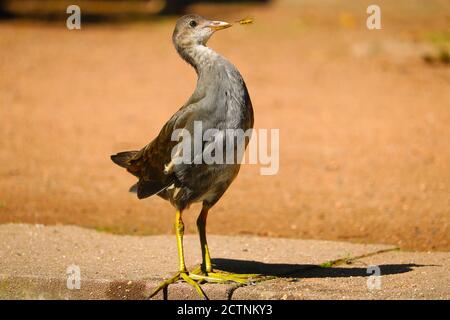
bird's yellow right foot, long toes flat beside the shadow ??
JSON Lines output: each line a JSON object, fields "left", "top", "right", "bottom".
{"left": 190, "top": 267, "right": 265, "bottom": 284}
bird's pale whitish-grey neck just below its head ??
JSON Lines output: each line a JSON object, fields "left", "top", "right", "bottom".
{"left": 177, "top": 44, "right": 221, "bottom": 74}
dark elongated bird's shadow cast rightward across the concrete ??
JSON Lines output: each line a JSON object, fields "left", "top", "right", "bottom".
{"left": 211, "top": 258, "right": 425, "bottom": 278}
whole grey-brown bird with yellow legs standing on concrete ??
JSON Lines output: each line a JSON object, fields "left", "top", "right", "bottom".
{"left": 111, "top": 14, "right": 258, "bottom": 299}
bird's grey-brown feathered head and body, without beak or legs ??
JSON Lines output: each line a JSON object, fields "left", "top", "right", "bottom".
{"left": 111, "top": 15, "right": 253, "bottom": 210}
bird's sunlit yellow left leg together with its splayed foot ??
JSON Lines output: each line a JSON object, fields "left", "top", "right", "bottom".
{"left": 149, "top": 210, "right": 207, "bottom": 299}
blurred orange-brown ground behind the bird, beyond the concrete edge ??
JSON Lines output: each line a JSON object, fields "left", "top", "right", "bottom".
{"left": 0, "top": 0, "right": 450, "bottom": 250}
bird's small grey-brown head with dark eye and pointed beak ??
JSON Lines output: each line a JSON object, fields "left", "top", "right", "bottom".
{"left": 172, "top": 14, "right": 232, "bottom": 49}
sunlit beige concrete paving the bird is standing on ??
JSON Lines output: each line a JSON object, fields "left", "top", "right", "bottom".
{"left": 0, "top": 224, "right": 450, "bottom": 299}
